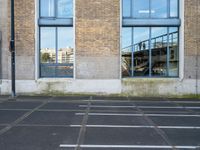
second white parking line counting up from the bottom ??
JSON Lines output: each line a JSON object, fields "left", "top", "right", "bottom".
{"left": 70, "top": 125, "right": 200, "bottom": 129}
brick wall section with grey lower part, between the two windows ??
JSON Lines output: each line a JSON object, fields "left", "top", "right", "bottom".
{"left": 75, "top": 0, "right": 120, "bottom": 79}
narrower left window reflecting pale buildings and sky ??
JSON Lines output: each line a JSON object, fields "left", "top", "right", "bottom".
{"left": 39, "top": 0, "right": 74, "bottom": 77}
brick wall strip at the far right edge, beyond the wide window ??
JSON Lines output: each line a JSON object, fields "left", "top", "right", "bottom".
{"left": 184, "top": 0, "right": 200, "bottom": 79}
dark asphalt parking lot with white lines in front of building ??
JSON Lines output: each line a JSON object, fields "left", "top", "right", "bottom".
{"left": 0, "top": 97, "right": 200, "bottom": 150}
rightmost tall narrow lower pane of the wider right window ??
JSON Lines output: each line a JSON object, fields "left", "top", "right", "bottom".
{"left": 169, "top": 27, "right": 179, "bottom": 77}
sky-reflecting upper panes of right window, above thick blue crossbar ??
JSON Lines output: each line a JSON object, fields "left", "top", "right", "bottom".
{"left": 123, "top": 0, "right": 178, "bottom": 18}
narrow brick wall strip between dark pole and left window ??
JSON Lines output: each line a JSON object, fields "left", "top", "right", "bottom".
{"left": 8, "top": 0, "right": 35, "bottom": 80}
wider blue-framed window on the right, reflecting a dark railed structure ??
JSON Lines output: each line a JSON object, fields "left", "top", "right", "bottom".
{"left": 121, "top": 0, "right": 180, "bottom": 77}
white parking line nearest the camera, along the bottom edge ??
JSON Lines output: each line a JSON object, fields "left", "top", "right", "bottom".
{"left": 60, "top": 144, "right": 199, "bottom": 149}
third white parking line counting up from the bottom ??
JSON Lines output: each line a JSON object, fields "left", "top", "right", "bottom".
{"left": 75, "top": 113, "right": 200, "bottom": 117}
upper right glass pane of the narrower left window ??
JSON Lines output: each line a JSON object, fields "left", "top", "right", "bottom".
{"left": 57, "top": 0, "right": 73, "bottom": 18}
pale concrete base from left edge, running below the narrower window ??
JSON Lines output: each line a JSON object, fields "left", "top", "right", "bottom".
{"left": 1, "top": 79, "right": 121, "bottom": 95}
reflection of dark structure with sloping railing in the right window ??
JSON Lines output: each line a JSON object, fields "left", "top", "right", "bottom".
{"left": 122, "top": 31, "right": 178, "bottom": 76}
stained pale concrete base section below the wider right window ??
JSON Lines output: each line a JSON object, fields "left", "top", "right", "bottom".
{"left": 122, "top": 78, "right": 200, "bottom": 97}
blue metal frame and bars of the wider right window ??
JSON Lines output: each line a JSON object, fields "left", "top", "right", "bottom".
{"left": 121, "top": 0, "right": 181, "bottom": 78}
